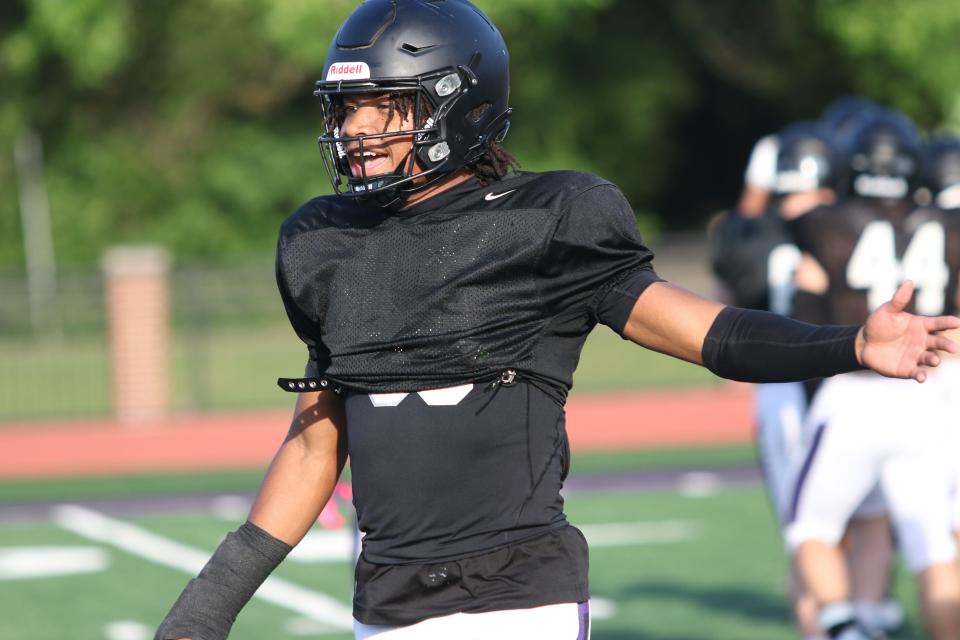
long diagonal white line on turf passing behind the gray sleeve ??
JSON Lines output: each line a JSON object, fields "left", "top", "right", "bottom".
{"left": 52, "top": 505, "right": 353, "bottom": 631}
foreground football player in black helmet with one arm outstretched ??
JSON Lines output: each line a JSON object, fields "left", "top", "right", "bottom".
{"left": 157, "top": 0, "right": 960, "bottom": 640}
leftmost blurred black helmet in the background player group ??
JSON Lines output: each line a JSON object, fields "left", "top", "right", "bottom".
{"left": 774, "top": 121, "right": 840, "bottom": 194}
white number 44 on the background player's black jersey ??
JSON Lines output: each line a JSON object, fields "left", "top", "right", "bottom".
{"left": 847, "top": 221, "right": 950, "bottom": 316}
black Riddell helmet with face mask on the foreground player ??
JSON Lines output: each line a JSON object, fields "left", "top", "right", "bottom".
{"left": 314, "top": 0, "right": 511, "bottom": 206}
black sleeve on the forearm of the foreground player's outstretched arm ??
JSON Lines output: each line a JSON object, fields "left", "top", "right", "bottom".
{"left": 702, "top": 307, "right": 863, "bottom": 382}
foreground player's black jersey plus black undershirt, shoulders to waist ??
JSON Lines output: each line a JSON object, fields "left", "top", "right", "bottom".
{"left": 277, "top": 172, "right": 658, "bottom": 624}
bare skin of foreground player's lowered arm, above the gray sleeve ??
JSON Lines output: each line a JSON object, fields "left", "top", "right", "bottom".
{"left": 249, "top": 391, "right": 347, "bottom": 546}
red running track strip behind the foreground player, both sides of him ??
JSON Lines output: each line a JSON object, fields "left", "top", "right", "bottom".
{"left": 0, "top": 384, "right": 753, "bottom": 480}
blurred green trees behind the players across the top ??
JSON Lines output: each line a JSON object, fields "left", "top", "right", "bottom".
{"left": 0, "top": 0, "right": 960, "bottom": 270}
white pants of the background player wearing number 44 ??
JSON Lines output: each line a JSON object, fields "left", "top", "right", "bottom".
{"left": 787, "top": 372, "right": 955, "bottom": 572}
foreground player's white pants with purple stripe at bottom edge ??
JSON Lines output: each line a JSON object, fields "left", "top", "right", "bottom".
{"left": 353, "top": 602, "right": 590, "bottom": 640}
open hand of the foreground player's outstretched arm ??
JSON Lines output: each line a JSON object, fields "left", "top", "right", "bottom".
{"left": 856, "top": 280, "right": 960, "bottom": 382}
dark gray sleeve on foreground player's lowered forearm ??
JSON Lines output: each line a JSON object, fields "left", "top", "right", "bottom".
{"left": 154, "top": 522, "right": 293, "bottom": 640}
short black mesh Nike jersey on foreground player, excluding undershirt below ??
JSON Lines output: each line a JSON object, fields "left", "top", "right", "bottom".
{"left": 277, "top": 171, "right": 657, "bottom": 397}
